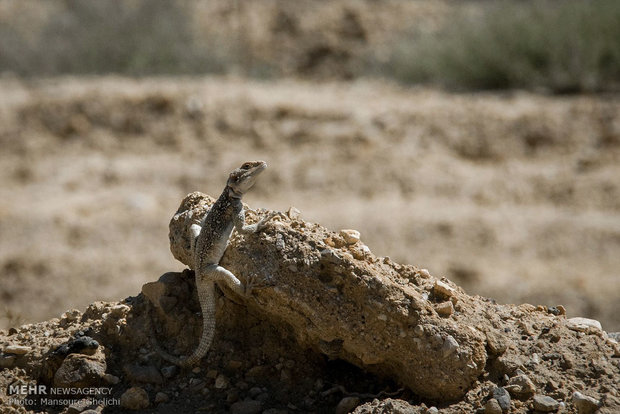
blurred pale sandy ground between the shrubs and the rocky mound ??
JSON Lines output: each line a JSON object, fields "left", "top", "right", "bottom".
{"left": 0, "top": 77, "right": 620, "bottom": 331}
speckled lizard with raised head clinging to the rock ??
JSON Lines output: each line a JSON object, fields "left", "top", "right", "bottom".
{"left": 151, "top": 161, "right": 278, "bottom": 367}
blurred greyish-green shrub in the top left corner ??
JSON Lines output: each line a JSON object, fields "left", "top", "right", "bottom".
{"left": 0, "top": 0, "right": 227, "bottom": 76}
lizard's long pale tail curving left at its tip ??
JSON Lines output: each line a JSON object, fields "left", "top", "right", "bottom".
{"left": 151, "top": 275, "right": 215, "bottom": 367}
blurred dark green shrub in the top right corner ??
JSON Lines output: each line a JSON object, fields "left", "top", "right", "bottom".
{"left": 387, "top": 0, "right": 620, "bottom": 93}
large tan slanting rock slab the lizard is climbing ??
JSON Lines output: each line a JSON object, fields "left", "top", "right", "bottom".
{"left": 170, "top": 193, "right": 487, "bottom": 400}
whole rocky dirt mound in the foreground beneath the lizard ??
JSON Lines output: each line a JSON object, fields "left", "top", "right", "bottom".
{"left": 0, "top": 193, "right": 620, "bottom": 413}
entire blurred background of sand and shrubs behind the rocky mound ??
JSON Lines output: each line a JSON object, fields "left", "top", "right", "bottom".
{"left": 0, "top": 0, "right": 620, "bottom": 331}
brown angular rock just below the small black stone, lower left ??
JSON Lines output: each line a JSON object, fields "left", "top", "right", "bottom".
{"left": 53, "top": 354, "right": 106, "bottom": 388}
